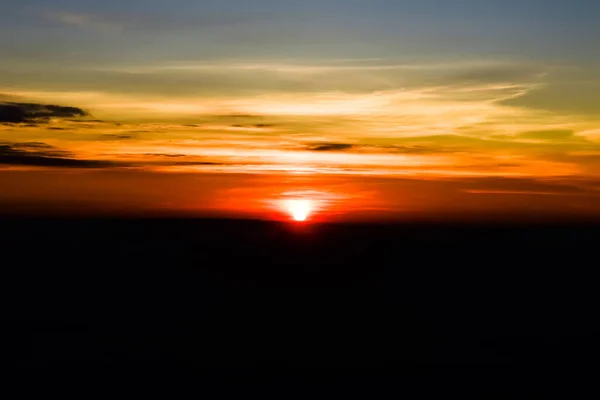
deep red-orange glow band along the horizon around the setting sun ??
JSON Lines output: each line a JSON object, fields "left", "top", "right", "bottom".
{"left": 0, "top": 170, "right": 600, "bottom": 225}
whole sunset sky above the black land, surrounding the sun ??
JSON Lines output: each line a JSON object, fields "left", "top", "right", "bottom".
{"left": 0, "top": 0, "right": 600, "bottom": 220}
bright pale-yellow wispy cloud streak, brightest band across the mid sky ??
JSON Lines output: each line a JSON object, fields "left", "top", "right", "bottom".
{"left": 1, "top": 84, "right": 558, "bottom": 141}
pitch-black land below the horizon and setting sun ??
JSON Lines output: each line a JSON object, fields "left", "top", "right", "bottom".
{"left": 0, "top": 219, "right": 600, "bottom": 398}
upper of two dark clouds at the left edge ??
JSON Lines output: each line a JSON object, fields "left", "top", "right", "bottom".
{"left": 0, "top": 102, "right": 88, "bottom": 123}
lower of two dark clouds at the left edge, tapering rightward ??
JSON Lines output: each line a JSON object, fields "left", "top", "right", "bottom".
{"left": 0, "top": 142, "right": 124, "bottom": 168}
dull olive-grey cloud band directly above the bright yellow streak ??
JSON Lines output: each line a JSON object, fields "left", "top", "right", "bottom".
{"left": 75, "top": 60, "right": 545, "bottom": 101}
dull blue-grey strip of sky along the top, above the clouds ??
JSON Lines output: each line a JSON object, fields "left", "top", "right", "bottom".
{"left": 0, "top": 0, "right": 600, "bottom": 63}
